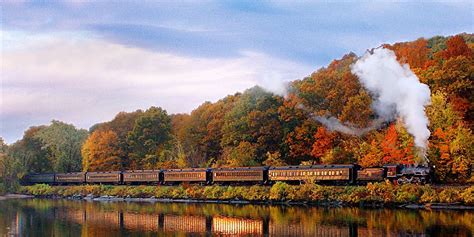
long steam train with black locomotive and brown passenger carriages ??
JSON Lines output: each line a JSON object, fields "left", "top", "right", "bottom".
{"left": 23, "top": 164, "right": 434, "bottom": 185}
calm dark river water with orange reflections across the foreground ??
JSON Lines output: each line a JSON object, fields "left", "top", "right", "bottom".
{"left": 0, "top": 199, "right": 474, "bottom": 236}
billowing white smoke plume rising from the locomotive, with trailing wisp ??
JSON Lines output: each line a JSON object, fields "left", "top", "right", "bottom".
{"left": 315, "top": 48, "right": 431, "bottom": 157}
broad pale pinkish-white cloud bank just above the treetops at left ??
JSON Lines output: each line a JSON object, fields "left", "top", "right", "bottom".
{"left": 0, "top": 32, "right": 312, "bottom": 142}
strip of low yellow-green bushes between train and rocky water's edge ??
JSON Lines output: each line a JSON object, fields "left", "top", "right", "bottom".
{"left": 20, "top": 183, "right": 474, "bottom": 206}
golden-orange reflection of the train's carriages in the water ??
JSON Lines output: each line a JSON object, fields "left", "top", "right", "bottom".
{"left": 55, "top": 207, "right": 357, "bottom": 237}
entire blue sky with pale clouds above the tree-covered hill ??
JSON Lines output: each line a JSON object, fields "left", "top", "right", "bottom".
{"left": 0, "top": 0, "right": 474, "bottom": 143}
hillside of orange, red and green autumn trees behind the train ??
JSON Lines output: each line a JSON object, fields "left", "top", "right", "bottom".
{"left": 0, "top": 34, "right": 474, "bottom": 191}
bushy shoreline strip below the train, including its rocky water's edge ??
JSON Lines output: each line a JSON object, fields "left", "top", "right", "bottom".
{"left": 14, "top": 183, "right": 474, "bottom": 210}
